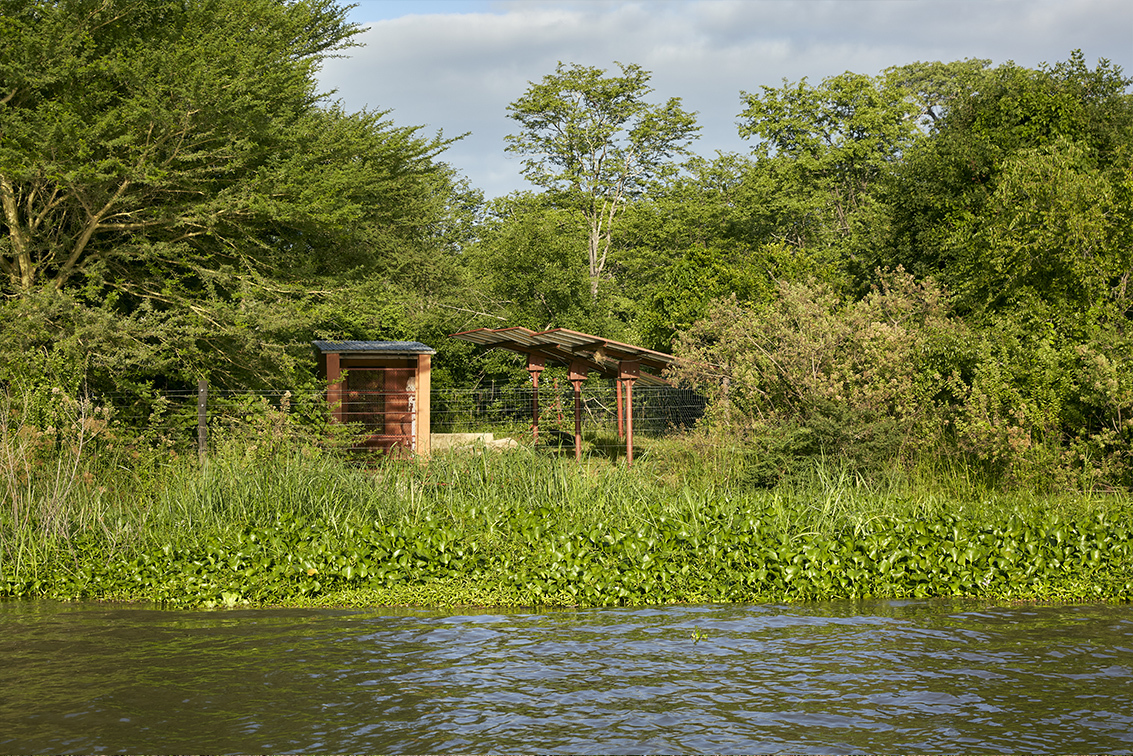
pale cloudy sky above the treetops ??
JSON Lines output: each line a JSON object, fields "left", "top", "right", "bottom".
{"left": 320, "top": 0, "right": 1133, "bottom": 197}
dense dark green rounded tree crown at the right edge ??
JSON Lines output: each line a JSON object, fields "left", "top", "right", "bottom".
{"left": 885, "top": 52, "right": 1133, "bottom": 321}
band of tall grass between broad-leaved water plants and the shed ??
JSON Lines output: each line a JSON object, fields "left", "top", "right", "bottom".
{"left": 0, "top": 394, "right": 1130, "bottom": 593}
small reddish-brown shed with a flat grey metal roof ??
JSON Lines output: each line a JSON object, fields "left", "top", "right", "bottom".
{"left": 313, "top": 341, "right": 436, "bottom": 457}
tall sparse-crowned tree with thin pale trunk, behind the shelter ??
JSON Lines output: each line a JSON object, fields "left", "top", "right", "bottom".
{"left": 506, "top": 62, "right": 700, "bottom": 297}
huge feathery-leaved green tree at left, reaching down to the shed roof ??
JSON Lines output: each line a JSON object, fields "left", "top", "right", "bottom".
{"left": 0, "top": 0, "right": 476, "bottom": 394}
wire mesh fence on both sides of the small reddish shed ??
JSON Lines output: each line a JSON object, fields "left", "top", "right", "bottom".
{"left": 46, "top": 381, "right": 706, "bottom": 452}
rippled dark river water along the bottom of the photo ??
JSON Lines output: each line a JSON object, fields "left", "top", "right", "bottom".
{"left": 0, "top": 601, "right": 1133, "bottom": 754}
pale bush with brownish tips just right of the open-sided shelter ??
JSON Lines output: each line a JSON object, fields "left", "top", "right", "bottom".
{"left": 675, "top": 270, "right": 964, "bottom": 468}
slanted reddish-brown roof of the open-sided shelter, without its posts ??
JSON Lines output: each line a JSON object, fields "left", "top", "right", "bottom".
{"left": 452, "top": 326, "right": 679, "bottom": 385}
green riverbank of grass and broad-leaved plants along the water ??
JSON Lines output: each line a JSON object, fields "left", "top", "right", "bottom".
{"left": 0, "top": 439, "right": 1133, "bottom": 608}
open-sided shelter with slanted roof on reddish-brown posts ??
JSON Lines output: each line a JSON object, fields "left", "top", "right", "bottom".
{"left": 452, "top": 328, "right": 678, "bottom": 465}
